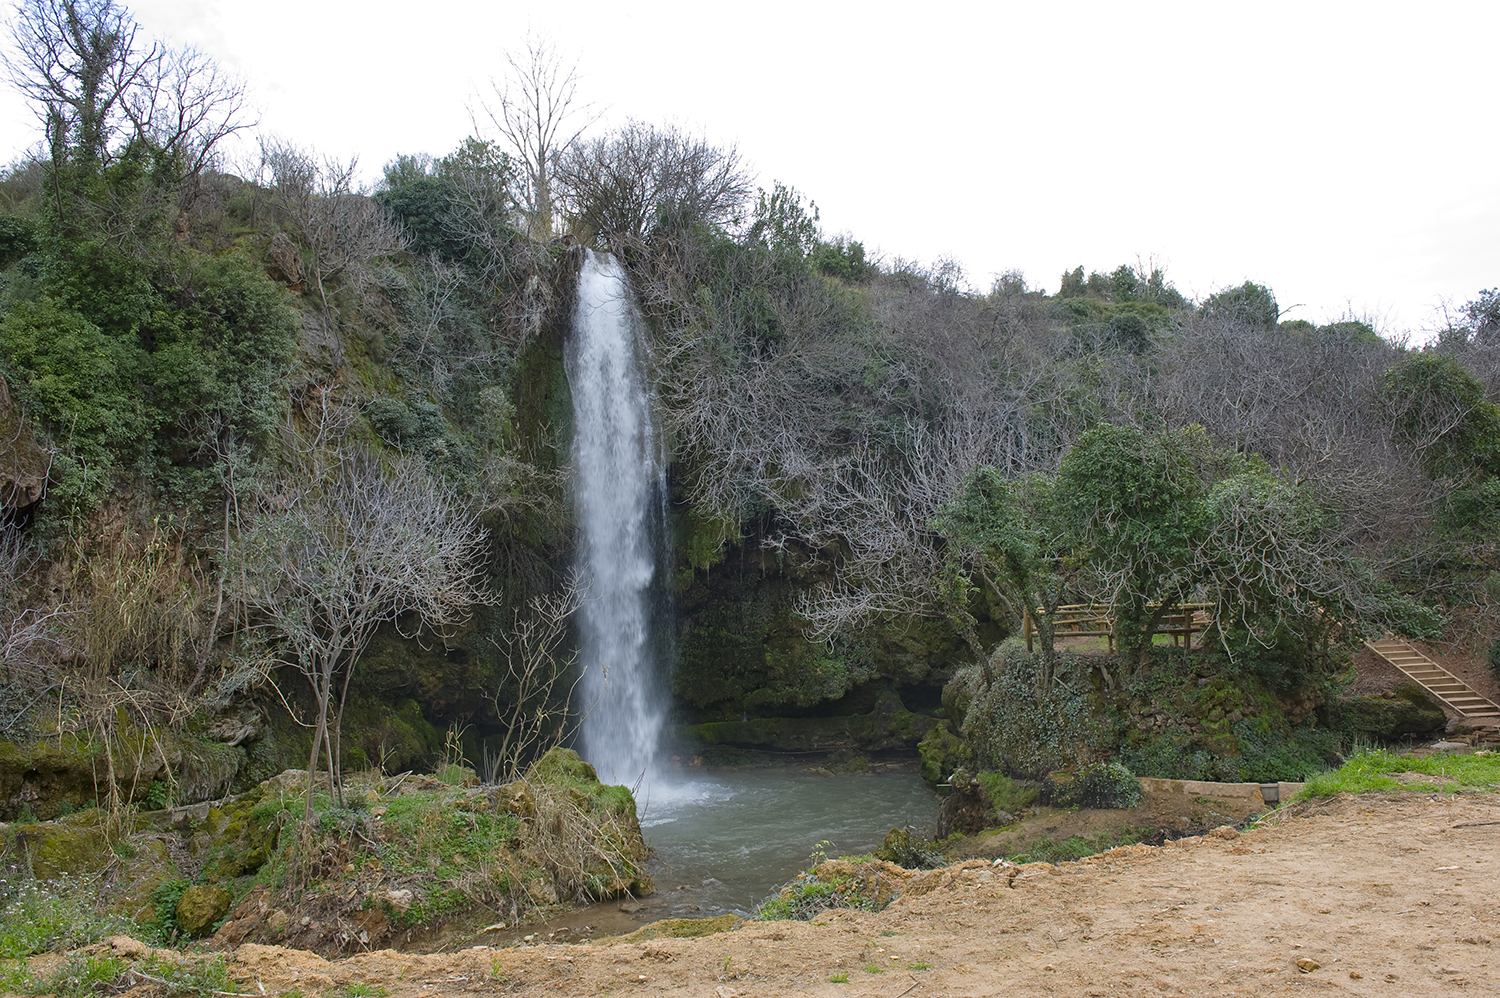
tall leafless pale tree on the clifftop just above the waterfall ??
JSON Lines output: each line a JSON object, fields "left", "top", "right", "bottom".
{"left": 480, "top": 38, "right": 599, "bottom": 240}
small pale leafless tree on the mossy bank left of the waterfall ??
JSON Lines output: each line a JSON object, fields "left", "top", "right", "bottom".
{"left": 237, "top": 455, "right": 494, "bottom": 818}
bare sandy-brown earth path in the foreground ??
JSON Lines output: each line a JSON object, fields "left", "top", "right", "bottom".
{"left": 193, "top": 792, "right": 1500, "bottom": 998}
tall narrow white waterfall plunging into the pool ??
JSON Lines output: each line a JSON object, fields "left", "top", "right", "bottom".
{"left": 564, "top": 252, "right": 665, "bottom": 786}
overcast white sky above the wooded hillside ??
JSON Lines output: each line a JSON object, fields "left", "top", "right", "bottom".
{"left": 0, "top": 0, "right": 1500, "bottom": 338}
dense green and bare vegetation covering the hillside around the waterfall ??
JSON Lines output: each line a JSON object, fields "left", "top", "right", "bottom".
{"left": 0, "top": 0, "right": 1500, "bottom": 834}
